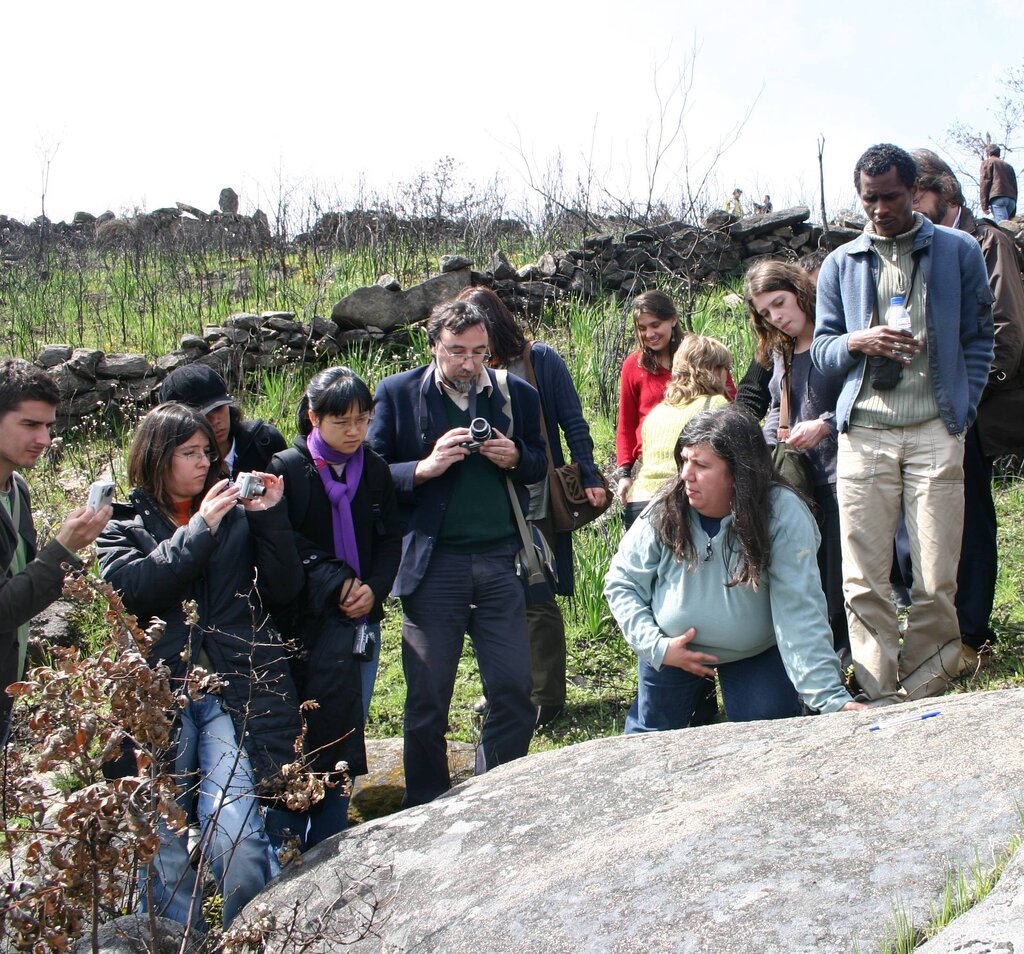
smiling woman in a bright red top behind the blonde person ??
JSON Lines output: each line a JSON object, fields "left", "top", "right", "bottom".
{"left": 615, "top": 289, "right": 736, "bottom": 507}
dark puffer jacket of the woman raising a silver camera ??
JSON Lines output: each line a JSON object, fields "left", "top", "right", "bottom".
{"left": 96, "top": 488, "right": 304, "bottom": 783}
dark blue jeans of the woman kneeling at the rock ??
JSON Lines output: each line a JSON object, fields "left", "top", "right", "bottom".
{"left": 626, "top": 646, "right": 800, "bottom": 735}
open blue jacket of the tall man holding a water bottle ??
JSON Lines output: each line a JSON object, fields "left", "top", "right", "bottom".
{"left": 811, "top": 213, "right": 993, "bottom": 434}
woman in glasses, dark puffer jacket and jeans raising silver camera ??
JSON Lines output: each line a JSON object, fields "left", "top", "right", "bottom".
{"left": 96, "top": 403, "right": 304, "bottom": 925}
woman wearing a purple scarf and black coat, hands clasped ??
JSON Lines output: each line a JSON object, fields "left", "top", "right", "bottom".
{"left": 269, "top": 367, "right": 401, "bottom": 848}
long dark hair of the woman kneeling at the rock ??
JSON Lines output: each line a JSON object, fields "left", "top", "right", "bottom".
{"left": 650, "top": 405, "right": 779, "bottom": 589}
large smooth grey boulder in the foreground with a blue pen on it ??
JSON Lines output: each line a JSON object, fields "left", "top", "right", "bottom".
{"left": 243, "top": 690, "right": 1024, "bottom": 954}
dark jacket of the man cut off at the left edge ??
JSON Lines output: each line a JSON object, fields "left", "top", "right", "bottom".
{"left": 0, "top": 474, "right": 82, "bottom": 735}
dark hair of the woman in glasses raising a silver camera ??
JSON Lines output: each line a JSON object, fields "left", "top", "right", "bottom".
{"left": 128, "top": 401, "right": 220, "bottom": 514}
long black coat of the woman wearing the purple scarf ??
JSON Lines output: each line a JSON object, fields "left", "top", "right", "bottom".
{"left": 268, "top": 437, "right": 401, "bottom": 775}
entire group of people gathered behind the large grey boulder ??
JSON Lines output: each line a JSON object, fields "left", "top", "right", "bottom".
{"left": 0, "top": 138, "right": 1024, "bottom": 923}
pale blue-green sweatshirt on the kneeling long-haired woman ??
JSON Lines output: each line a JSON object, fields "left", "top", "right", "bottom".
{"left": 604, "top": 486, "right": 850, "bottom": 712}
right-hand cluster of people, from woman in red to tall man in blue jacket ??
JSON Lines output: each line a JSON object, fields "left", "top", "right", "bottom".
{"left": 605, "top": 143, "right": 1024, "bottom": 732}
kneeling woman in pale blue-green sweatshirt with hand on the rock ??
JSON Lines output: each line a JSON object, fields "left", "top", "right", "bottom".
{"left": 604, "top": 407, "right": 863, "bottom": 733}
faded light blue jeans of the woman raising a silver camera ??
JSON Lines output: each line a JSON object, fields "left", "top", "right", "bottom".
{"left": 142, "top": 695, "right": 281, "bottom": 927}
